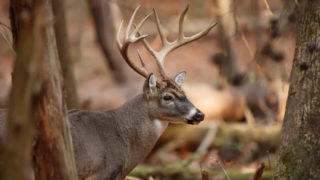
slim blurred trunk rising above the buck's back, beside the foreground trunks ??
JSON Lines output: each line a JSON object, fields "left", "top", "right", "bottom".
{"left": 52, "top": 0, "right": 79, "bottom": 109}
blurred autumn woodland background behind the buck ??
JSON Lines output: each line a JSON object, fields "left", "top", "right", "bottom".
{"left": 0, "top": 0, "right": 295, "bottom": 179}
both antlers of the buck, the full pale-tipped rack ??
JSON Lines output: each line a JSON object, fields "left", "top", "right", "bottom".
{"left": 117, "top": 5, "right": 217, "bottom": 80}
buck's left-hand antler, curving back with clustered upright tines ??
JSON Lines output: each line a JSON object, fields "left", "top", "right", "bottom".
{"left": 117, "top": 5, "right": 152, "bottom": 78}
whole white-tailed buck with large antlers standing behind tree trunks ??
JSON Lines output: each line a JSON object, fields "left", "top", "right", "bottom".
{"left": 0, "top": 4, "right": 215, "bottom": 180}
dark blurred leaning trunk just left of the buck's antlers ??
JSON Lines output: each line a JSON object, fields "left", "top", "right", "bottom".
{"left": 88, "top": 0, "right": 126, "bottom": 84}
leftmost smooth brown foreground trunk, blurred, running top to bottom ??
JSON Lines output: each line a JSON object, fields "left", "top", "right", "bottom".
{"left": 0, "top": 0, "right": 44, "bottom": 180}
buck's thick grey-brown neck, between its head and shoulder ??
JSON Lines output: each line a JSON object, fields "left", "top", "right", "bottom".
{"left": 116, "top": 94, "right": 168, "bottom": 171}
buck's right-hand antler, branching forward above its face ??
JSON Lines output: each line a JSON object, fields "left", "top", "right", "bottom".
{"left": 142, "top": 5, "right": 217, "bottom": 79}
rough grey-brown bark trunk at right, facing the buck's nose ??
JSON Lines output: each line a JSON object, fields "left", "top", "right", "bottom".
{"left": 275, "top": 0, "right": 320, "bottom": 180}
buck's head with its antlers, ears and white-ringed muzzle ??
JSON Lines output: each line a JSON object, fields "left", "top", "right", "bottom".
{"left": 117, "top": 6, "right": 216, "bottom": 124}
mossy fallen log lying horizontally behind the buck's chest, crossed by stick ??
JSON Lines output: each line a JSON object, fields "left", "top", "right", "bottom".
{"left": 156, "top": 121, "right": 281, "bottom": 151}
